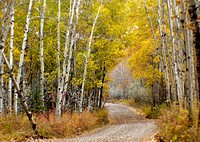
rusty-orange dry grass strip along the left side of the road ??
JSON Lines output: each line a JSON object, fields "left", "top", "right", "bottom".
{"left": 0, "top": 109, "right": 108, "bottom": 141}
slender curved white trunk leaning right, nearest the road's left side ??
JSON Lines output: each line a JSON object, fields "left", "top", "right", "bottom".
{"left": 79, "top": 0, "right": 103, "bottom": 113}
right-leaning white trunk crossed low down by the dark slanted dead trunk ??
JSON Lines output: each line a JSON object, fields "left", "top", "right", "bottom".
{"left": 14, "top": 0, "right": 33, "bottom": 114}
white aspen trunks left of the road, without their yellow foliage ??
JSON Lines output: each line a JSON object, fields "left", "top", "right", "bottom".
{"left": 0, "top": 0, "right": 106, "bottom": 135}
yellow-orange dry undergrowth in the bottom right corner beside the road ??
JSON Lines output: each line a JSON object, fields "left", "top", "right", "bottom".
{"left": 158, "top": 106, "right": 200, "bottom": 142}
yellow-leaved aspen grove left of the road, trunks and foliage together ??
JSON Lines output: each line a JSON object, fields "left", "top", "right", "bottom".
{"left": 0, "top": 0, "right": 131, "bottom": 133}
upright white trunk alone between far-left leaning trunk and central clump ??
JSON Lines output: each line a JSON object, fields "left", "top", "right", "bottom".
{"left": 40, "top": 0, "right": 46, "bottom": 107}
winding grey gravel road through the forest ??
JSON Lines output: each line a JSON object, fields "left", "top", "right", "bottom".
{"left": 57, "top": 103, "right": 157, "bottom": 142}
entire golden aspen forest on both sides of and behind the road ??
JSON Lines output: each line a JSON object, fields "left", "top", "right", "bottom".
{"left": 0, "top": 0, "right": 200, "bottom": 139}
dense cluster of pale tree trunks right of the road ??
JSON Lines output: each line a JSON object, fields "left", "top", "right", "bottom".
{"left": 145, "top": 0, "right": 200, "bottom": 127}
